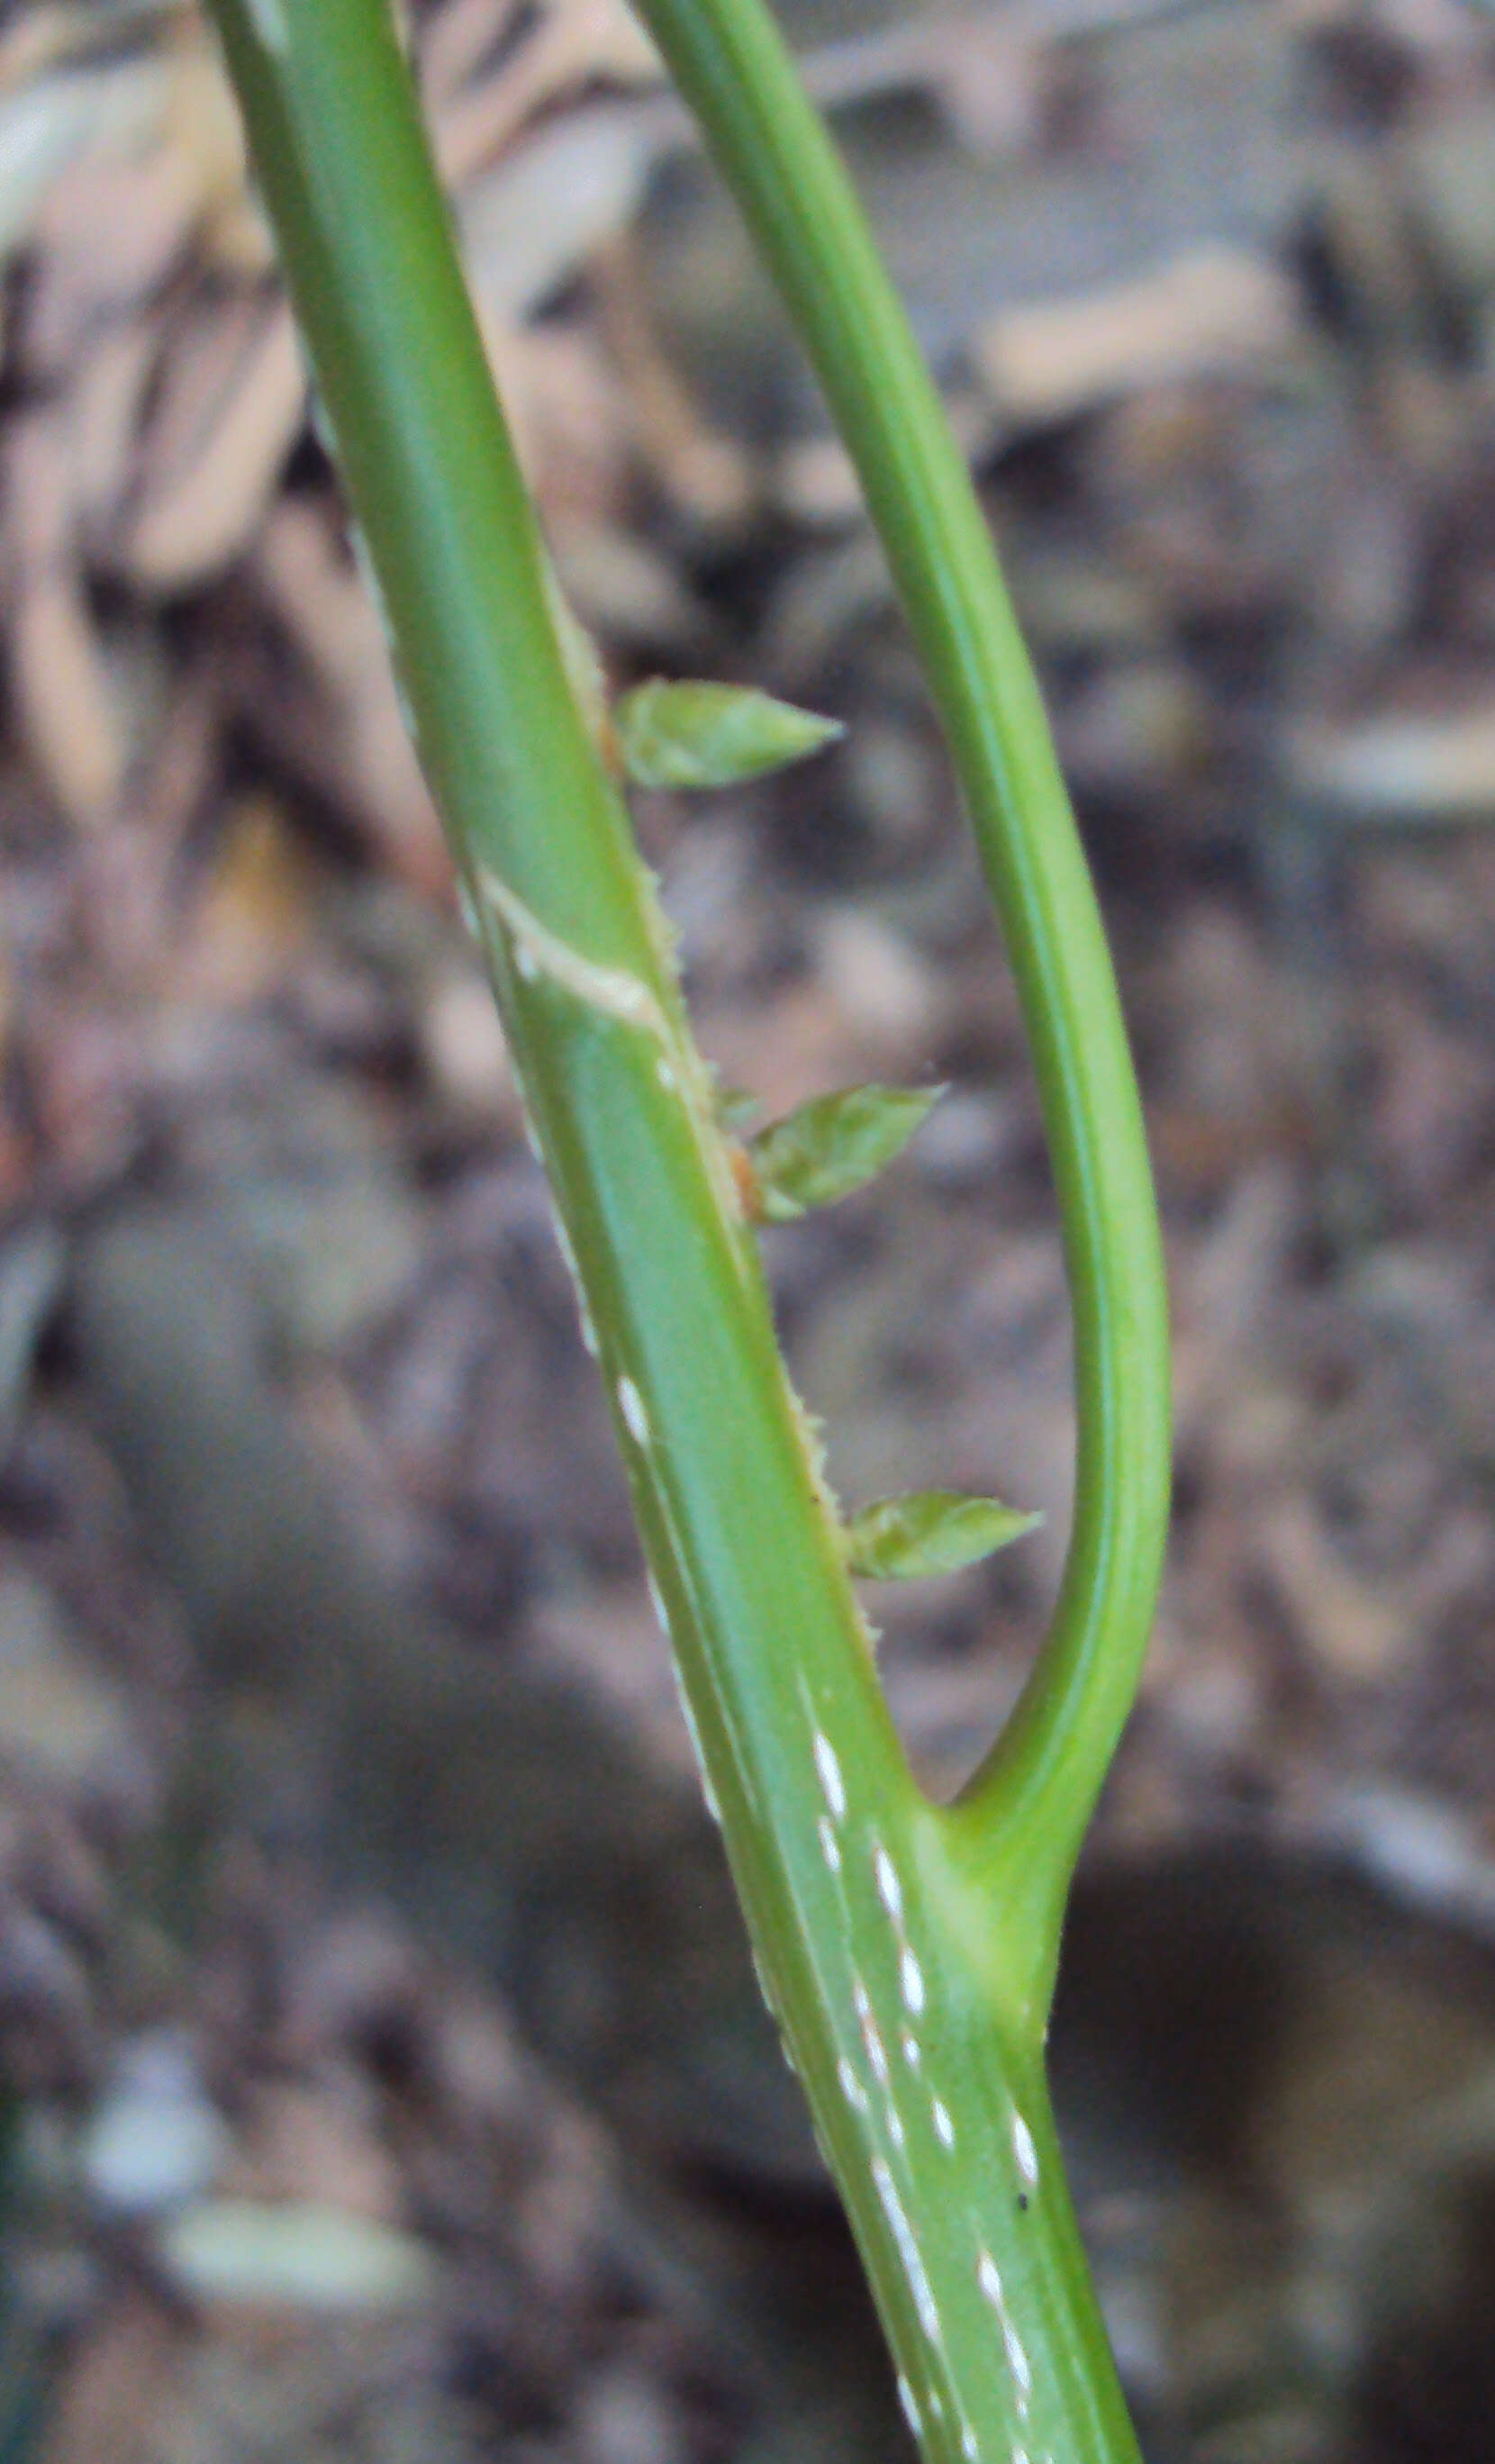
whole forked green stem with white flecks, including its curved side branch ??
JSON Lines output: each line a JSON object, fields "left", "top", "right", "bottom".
{"left": 204, "top": 0, "right": 1165, "bottom": 2464}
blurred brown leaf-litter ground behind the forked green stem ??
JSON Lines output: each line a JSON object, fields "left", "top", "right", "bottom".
{"left": 0, "top": 0, "right": 1495, "bottom": 2464}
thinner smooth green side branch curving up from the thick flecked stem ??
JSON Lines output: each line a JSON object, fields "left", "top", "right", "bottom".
{"left": 625, "top": 0, "right": 1170, "bottom": 2001}
